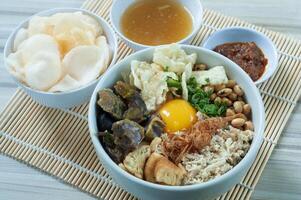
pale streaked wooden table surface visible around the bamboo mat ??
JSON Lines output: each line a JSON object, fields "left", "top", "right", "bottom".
{"left": 0, "top": 0, "right": 301, "bottom": 200}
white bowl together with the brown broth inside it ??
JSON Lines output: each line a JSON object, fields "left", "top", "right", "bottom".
{"left": 110, "top": 0, "right": 203, "bottom": 50}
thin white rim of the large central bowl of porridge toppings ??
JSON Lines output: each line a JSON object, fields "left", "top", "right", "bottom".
{"left": 88, "top": 44, "right": 265, "bottom": 192}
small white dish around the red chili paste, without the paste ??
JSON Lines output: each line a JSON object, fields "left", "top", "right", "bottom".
{"left": 202, "top": 27, "right": 278, "bottom": 84}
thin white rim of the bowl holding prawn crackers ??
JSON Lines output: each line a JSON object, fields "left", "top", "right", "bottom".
{"left": 3, "top": 7, "right": 118, "bottom": 96}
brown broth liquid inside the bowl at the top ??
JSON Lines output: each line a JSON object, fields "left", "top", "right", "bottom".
{"left": 121, "top": 0, "right": 192, "bottom": 46}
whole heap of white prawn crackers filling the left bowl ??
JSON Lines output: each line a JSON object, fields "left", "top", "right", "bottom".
{"left": 6, "top": 12, "right": 111, "bottom": 92}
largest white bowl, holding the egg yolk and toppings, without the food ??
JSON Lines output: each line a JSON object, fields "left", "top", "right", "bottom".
{"left": 89, "top": 45, "right": 265, "bottom": 200}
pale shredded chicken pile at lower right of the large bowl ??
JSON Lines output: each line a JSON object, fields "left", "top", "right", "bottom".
{"left": 181, "top": 126, "right": 254, "bottom": 185}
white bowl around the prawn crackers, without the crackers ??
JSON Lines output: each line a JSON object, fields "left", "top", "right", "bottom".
{"left": 4, "top": 8, "right": 117, "bottom": 108}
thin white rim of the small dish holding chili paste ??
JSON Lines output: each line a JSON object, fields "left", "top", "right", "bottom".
{"left": 202, "top": 26, "right": 279, "bottom": 85}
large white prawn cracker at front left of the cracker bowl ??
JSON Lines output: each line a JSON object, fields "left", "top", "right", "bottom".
{"left": 7, "top": 34, "right": 61, "bottom": 91}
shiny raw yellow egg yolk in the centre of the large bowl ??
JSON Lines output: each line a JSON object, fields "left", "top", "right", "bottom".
{"left": 159, "top": 99, "right": 196, "bottom": 133}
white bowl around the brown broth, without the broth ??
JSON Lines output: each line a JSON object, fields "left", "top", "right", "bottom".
{"left": 110, "top": 0, "right": 203, "bottom": 51}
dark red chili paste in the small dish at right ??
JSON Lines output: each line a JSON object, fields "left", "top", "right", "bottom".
{"left": 213, "top": 42, "right": 268, "bottom": 81}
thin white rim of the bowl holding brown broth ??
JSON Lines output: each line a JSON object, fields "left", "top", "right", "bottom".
{"left": 110, "top": 0, "right": 204, "bottom": 49}
